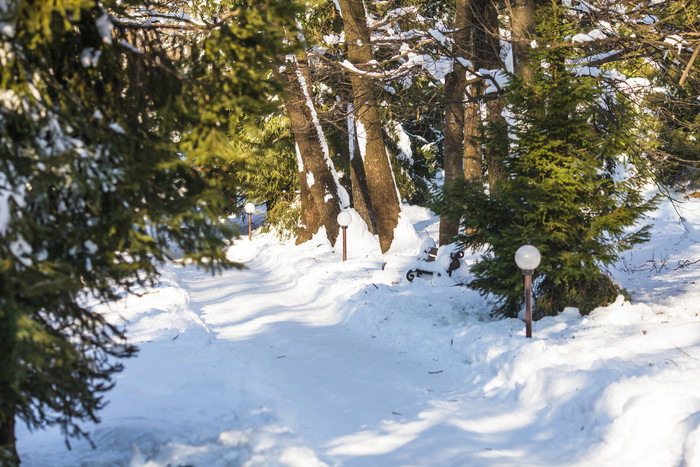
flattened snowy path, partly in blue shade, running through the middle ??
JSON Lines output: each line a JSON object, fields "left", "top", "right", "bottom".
{"left": 175, "top": 250, "right": 478, "bottom": 465}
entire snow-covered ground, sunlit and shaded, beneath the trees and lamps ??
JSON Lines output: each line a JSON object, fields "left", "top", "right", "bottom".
{"left": 18, "top": 196, "right": 700, "bottom": 467}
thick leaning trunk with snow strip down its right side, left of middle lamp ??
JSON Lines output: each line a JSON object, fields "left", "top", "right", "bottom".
{"left": 283, "top": 55, "right": 349, "bottom": 243}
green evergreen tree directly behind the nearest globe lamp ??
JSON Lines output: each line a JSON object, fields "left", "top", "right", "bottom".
{"left": 447, "top": 4, "right": 653, "bottom": 317}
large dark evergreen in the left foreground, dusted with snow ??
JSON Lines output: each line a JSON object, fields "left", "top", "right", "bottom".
{"left": 0, "top": 0, "right": 294, "bottom": 465}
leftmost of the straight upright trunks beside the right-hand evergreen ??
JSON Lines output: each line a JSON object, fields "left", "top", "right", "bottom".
{"left": 440, "top": 0, "right": 473, "bottom": 244}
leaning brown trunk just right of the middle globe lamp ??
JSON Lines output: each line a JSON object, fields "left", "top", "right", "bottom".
{"left": 338, "top": 0, "right": 401, "bottom": 253}
